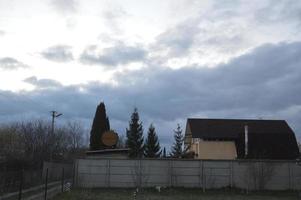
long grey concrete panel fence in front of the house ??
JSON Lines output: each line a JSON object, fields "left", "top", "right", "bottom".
{"left": 75, "top": 159, "right": 301, "bottom": 191}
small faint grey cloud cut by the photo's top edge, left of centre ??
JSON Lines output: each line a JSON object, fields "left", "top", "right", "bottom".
{"left": 50, "top": 0, "right": 78, "bottom": 14}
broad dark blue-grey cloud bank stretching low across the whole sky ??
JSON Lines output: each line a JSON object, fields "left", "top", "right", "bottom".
{"left": 0, "top": 42, "right": 301, "bottom": 144}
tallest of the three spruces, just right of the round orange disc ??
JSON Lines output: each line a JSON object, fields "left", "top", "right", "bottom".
{"left": 126, "top": 108, "right": 144, "bottom": 158}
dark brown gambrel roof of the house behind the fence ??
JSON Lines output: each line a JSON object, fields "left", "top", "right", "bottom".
{"left": 187, "top": 119, "right": 299, "bottom": 159}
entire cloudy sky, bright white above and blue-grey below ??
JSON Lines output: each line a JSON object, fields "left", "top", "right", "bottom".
{"left": 0, "top": 0, "right": 301, "bottom": 146}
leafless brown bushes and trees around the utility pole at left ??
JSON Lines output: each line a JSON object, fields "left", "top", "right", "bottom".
{"left": 0, "top": 120, "right": 84, "bottom": 169}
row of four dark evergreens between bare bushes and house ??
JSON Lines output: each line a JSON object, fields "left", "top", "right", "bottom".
{"left": 90, "top": 102, "right": 186, "bottom": 158}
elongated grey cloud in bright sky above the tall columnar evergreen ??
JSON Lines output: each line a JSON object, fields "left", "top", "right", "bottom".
{"left": 80, "top": 42, "right": 146, "bottom": 66}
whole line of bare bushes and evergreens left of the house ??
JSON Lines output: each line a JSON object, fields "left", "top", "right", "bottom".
{"left": 0, "top": 103, "right": 186, "bottom": 170}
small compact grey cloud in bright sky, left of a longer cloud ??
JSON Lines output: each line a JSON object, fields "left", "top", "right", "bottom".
{"left": 41, "top": 45, "right": 74, "bottom": 62}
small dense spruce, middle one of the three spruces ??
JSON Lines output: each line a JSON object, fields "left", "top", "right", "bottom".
{"left": 144, "top": 124, "right": 162, "bottom": 158}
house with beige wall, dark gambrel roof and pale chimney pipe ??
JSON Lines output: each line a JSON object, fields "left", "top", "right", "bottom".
{"left": 184, "top": 119, "right": 299, "bottom": 160}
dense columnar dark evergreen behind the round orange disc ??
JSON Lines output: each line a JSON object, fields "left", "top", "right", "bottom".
{"left": 90, "top": 102, "right": 110, "bottom": 150}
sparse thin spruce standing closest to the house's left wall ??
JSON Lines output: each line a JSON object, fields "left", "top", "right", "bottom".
{"left": 171, "top": 124, "right": 184, "bottom": 158}
